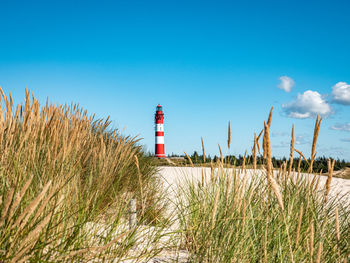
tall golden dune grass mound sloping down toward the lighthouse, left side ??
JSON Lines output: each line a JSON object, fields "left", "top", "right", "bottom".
{"left": 0, "top": 89, "right": 168, "bottom": 262}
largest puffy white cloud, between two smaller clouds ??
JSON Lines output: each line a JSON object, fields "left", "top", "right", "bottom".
{"left": 282, "top": 90, "right": 332, "bottom": 119}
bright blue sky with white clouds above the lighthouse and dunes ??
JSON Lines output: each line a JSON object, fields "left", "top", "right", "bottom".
{"left": 0, "top": 0, "right": 350, "bottom": 160}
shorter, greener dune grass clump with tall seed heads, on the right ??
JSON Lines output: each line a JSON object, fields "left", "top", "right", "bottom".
{"left": 177, "top": 110, "right": 350, "bottom": 262}
